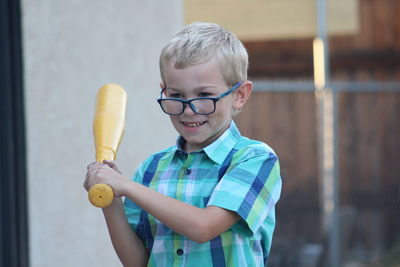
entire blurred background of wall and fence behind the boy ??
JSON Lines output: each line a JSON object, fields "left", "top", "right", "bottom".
{"left": 0, "top": 0, "right": 400, "bottom": 267}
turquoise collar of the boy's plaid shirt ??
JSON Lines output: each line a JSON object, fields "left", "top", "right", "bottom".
{"left": 176, "top": 120, "right": 241, "bottom": 165}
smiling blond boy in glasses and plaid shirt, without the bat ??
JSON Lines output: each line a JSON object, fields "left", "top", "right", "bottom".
{"left": 84, "top": 23, "right": 281, "bottom": 267}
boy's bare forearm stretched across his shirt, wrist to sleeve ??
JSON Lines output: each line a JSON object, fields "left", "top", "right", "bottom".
{"left": 125, "top": 182, "right": 239, "bottom": 243}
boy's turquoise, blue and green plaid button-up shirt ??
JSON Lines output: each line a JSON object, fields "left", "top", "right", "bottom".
{"left": 125, "top": 121, "right": 282, "bottom": 267}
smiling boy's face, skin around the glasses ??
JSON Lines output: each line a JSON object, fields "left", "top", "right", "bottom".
{"left": 161, "top": 59, "right": 235, "bottom": 152}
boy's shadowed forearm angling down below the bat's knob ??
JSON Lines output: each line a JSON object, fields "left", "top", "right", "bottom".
{"left": 103, "top": 199, "right": 148, "bottom": 266}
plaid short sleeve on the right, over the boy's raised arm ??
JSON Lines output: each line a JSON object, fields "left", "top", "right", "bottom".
{"left": 207, "top": 147, "right": 282, "bottom": 237}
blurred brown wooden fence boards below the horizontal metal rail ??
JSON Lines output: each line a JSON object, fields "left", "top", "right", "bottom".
{"left": 235, "top": 91, "right": 400, "bottom": 260}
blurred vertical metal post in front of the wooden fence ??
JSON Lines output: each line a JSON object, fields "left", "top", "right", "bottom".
{"left": 314, "top": 0, "right": 340, "bottom": 267}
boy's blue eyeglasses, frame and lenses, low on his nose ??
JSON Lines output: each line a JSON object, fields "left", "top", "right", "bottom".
{"left": 157, "top": 82, "right": 242, "bottom": 115}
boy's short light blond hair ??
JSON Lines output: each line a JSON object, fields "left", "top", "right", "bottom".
{"left": 160, "top": 22, "right": 248, "bottom": 86}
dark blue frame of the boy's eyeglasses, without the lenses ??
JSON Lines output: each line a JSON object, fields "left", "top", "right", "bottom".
{"left": 157, "top": 82, "right": 242, "bottom": 116}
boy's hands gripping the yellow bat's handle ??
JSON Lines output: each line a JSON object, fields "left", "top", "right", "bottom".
{"left": 83, "top": 160, "right": 129, "bottom": 197}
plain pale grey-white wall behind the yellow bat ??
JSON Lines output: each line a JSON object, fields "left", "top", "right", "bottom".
{"left": 22, "top": 0, "right": 183, "bottom": 267}
